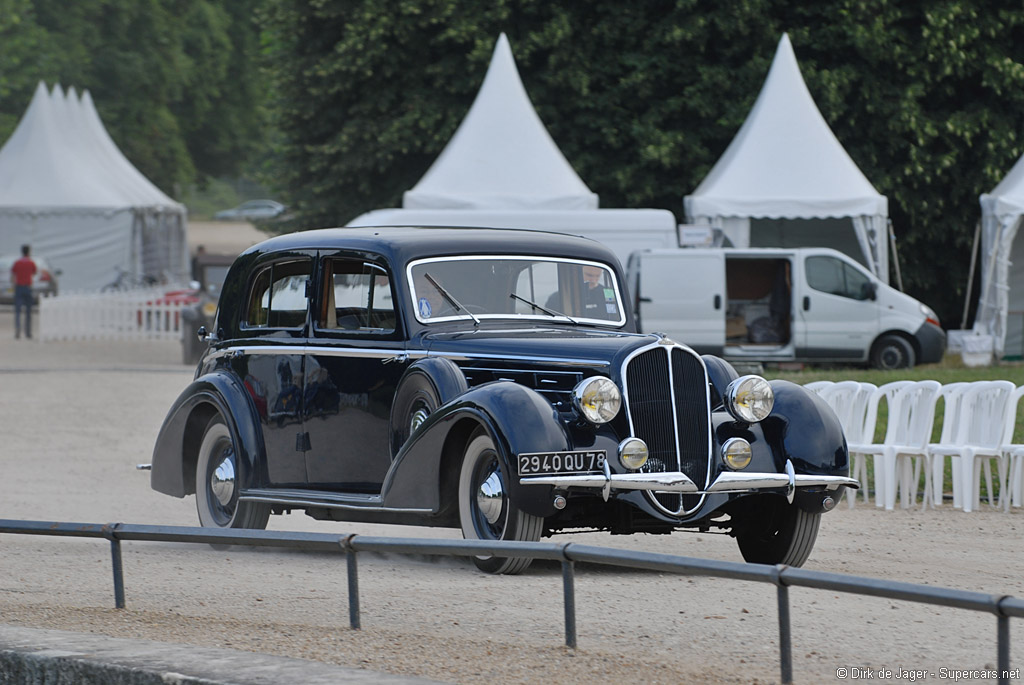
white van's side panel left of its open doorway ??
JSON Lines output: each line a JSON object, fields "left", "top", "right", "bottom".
{"left": 631, "top": 249, "right": 726, "bottom": 354}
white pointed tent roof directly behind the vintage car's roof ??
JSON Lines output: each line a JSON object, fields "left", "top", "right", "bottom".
{"left": 402, "top": 34, "right": 597, "bottom": 210}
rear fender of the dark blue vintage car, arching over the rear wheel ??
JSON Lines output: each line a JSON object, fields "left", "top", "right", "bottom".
{"left": 150, "top": 371, "right": 263, "bottom": 498}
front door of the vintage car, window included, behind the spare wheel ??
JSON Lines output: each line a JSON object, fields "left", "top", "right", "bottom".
{"left": 303, "top": 255, "right": 408, "bottom": 493}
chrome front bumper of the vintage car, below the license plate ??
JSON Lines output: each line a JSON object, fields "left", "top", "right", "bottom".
{"left": 519, "top": 461, "right": 860, "bottom": 499}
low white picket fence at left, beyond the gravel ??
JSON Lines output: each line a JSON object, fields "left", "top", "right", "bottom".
{"left": 38, "top": 286, "right": 192, "bottom": 341}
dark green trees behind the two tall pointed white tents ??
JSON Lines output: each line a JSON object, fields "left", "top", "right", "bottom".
{"left": 262, "top": 0, "right": 1024, "bottom": 327}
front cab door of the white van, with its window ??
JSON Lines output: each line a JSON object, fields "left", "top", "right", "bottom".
{"left": 797, "top": 250, "right": 879, "bottom": 360}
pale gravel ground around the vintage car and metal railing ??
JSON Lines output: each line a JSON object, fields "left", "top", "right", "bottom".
{"left": 0, "top": 301, "right": 1024, "bottom": 683}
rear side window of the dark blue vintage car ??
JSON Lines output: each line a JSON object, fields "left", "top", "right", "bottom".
{"left": 246, "top": 259, "right": 310, "bottom": 329}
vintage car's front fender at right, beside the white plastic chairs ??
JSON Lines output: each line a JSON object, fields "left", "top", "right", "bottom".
{"left": 761, "top": 380, "right": 850, "bottom": 476}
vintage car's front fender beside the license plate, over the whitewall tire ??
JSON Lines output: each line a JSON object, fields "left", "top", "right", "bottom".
{"left": 382, "top": 381, "right": 571, "bottom": 516}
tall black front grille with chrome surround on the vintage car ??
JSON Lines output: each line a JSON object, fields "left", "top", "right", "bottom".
{"left": 623, "top": 344, "right": 711, "bottom": 514}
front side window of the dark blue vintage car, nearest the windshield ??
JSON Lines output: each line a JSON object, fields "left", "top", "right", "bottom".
{"left": 316, "top": 259, "right": 396, "bottom": 333}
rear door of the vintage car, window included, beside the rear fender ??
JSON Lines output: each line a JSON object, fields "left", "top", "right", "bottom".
{"left": 229, "top": 254, "right": 313, "bottom": 485}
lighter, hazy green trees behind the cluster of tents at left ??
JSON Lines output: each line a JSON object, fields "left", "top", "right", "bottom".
{"left": 0, "top": 0, "right": 265, "bottom": 197}
